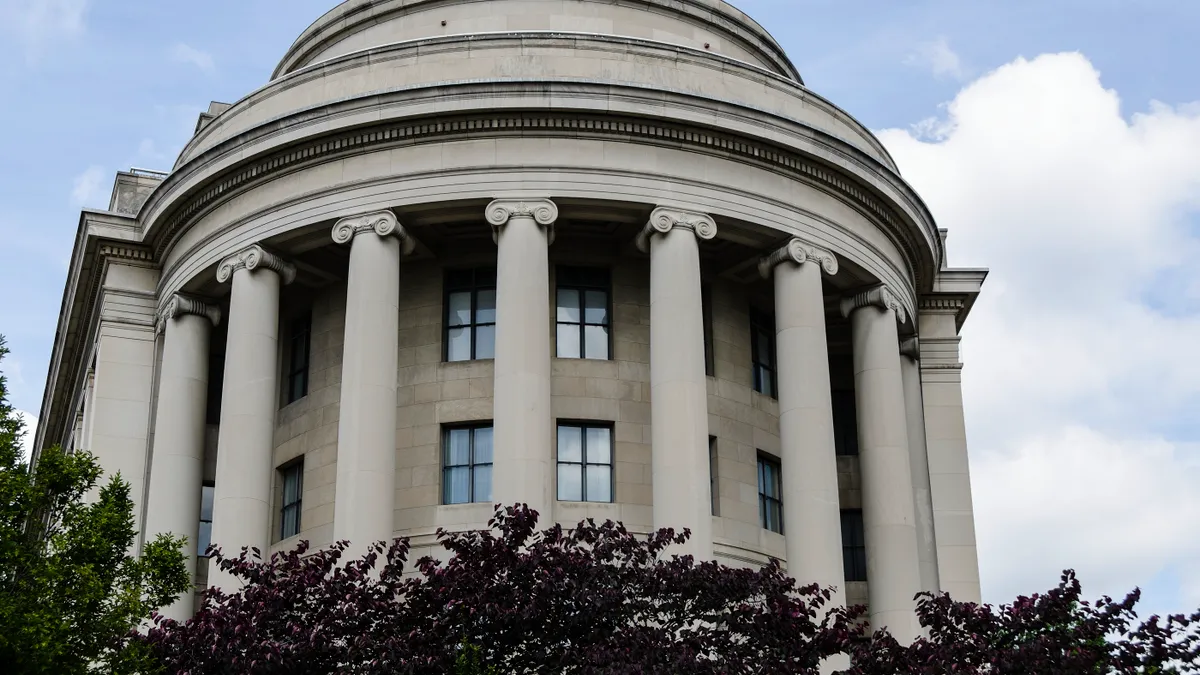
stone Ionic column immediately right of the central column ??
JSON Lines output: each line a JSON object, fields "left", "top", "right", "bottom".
{"left": 637, "top": 208, "right": 716, "bottom": 560}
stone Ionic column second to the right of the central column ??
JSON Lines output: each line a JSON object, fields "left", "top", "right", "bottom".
{"left": 758, "top": 239, "right": 846, "bottom": 607}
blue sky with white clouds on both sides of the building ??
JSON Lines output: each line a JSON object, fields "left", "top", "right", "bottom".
{"left": 0, "top": 0, "right": 1200, "bottom": 613}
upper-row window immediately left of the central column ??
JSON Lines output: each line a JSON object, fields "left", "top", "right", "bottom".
{"left": 444, "top": 268, "right": 496, "bottom": 362}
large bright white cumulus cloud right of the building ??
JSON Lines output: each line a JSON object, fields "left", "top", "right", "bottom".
{"left": 881, "top": 54, "right": 1200, "bottom": 610}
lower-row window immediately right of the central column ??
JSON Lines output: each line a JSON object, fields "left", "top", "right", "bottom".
{"left": 558, "top": 424, "right": 612, "bottom": 502}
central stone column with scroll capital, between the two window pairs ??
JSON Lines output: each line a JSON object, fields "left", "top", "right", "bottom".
{"left": 486, "top": 199, "right": 558, "bottom": 516}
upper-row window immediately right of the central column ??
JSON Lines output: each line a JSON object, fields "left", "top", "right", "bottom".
{"left": 556, "top": 267, "right": 612, "bottom": 359}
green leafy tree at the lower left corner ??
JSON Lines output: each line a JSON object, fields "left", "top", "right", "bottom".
{"left": 0, "top": 336, "right": 191, "bottom": 675}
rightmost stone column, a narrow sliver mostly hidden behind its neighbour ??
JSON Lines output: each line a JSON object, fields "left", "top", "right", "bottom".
{"left": 900, "top": 338, "right": 941, "bottom": 593}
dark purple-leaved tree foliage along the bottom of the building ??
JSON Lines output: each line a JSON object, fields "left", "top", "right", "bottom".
{"left": 132, "top": 507, "right": 1200, "bottom": 675}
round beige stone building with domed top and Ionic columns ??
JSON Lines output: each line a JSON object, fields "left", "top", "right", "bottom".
{"left": 36, "top": 0, "right": 986, "bottom": 638}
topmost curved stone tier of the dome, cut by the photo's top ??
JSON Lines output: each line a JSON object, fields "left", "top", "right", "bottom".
{"left": 271, "top": 0, "right": 803, "bottom": 83}
